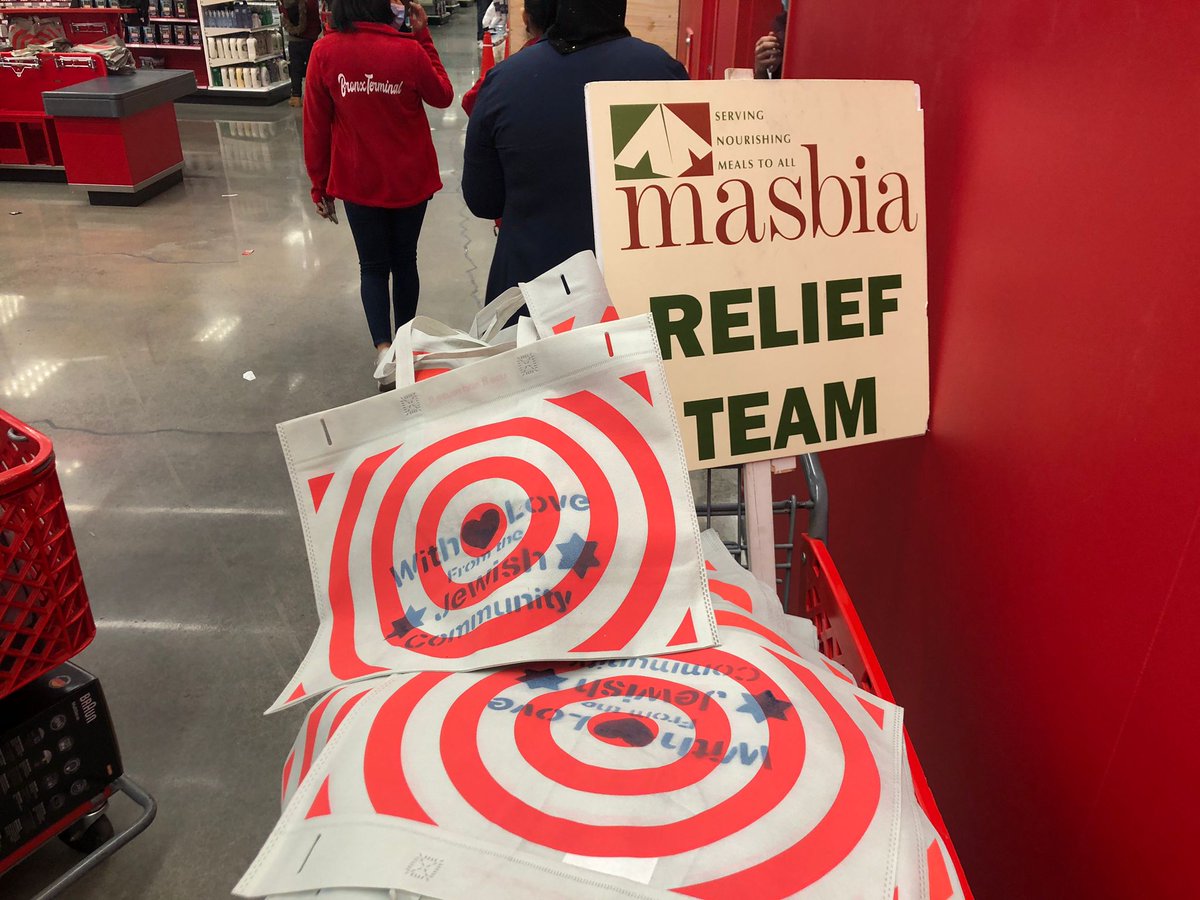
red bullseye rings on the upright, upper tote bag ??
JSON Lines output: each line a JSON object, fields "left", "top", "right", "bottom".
{"left": 329, "top": 384, "right": 677, "bottom": 680}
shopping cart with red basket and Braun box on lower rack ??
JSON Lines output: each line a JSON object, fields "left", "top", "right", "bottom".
{"left": 0, "top": 409, "right": 156, "bottom": 900}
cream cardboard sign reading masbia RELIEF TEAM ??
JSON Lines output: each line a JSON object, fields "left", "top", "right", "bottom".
{"left": 587, "top": 80, "right": 929, "bottom": 468}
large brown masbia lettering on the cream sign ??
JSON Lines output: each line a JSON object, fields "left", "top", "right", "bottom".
{"left": 614, "top": 146, "right": 917, "bottom": 250}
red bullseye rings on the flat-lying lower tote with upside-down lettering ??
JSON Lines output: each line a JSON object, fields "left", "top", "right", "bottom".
{"left": 350, "top": 650, "right": 882, "bottom": 898}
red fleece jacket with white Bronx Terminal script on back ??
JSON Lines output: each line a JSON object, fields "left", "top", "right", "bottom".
{"left": 304, "top": 22, "right": 454, "bottom": 209}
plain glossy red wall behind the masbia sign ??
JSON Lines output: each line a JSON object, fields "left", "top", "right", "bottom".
{"left": 785, "top": 0, "right": 1200, "bottom": 900}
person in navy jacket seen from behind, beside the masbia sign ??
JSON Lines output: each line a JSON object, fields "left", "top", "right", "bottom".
{"left": 462, "top": 0, "right": 688, "bottom": 301}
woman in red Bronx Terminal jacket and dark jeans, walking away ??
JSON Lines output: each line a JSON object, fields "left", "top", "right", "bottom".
{"left": 304, "top": 0, "right": 454, "bottom": 390}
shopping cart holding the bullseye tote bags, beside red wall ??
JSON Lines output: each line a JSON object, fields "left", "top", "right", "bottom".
{"left": 696, "top": 454, "right": 974, "bottom": 900}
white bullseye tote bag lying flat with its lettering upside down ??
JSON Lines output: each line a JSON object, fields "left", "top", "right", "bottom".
{"left": 235, "top": 629, "right": 904, "bottom": 900}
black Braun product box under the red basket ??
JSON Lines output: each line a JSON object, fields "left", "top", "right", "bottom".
{"left": 0, "top": 662, "right": 124, "bottom": 872}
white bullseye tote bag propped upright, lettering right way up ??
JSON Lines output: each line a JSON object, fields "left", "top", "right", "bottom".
{"left": 272, "top": 317, "right": 715, "bottom": 710}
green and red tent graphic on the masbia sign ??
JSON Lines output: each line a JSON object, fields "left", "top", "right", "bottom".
{"left": 610, "top": 103, "right": 713, "bottom": 181}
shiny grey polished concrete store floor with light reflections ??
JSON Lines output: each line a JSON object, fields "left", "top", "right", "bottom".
{"left": 0, "top": 6, "right": 493, "bottom": 900}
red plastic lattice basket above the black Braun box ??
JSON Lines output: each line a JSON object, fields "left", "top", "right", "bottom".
{"left": 0, "top": 409, "right": 96, "bottom": 697}
